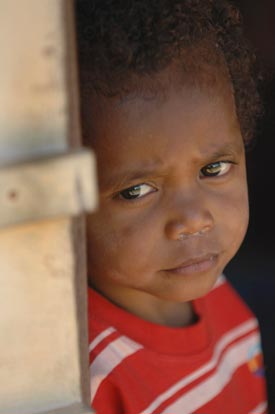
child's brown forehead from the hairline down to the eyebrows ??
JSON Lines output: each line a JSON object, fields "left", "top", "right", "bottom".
{"left": 92, "top": 84, "right": 243, "bottom": 191}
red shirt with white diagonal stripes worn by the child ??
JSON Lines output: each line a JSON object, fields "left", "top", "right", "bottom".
{"left": 89, "top": 277, "right": 267, "bottom": 414}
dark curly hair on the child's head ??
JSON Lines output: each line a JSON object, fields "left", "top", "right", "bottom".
{"left": 75, "top": 0, "right": 261, "bottom": 144}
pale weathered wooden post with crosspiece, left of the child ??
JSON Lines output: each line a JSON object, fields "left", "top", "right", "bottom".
{"left": 0, "top": 0, "right": 96, "bottom": 414}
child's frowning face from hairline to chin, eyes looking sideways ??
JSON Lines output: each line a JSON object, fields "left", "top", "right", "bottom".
{"left": 87, "top": 78, "right": 248, "bottom": 309}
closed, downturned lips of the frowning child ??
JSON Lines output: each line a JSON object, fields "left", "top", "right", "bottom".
{"left": 165, "top": 253, "right": 218, "bottom": 275}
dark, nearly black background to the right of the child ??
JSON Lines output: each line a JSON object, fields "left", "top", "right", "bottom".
{"left": 225, "top": 0, "right": 275, "bottom": 414}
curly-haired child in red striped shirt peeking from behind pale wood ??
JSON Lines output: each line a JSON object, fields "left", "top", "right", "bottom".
{"left": 76, "top": 0, "right": 267, "bottom": 414}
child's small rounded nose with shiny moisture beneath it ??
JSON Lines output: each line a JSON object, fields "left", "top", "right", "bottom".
{"left": 165, "top": 196, "right": 214, "bottom": 240}
